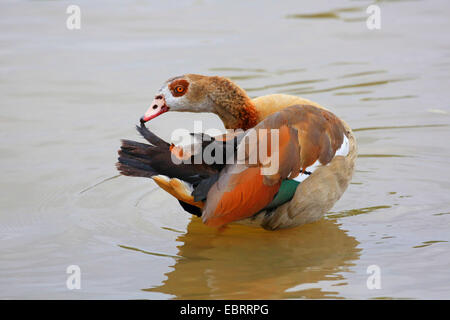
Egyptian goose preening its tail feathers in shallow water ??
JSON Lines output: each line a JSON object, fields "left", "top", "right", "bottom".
{"left": 117, "top": 74, "right": 357, "bottom": 230}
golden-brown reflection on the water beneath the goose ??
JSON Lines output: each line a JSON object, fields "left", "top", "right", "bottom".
{"left": 143, "top": 218, "right": 360, "bottom": 299}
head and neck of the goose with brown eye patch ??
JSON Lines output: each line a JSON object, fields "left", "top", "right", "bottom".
{"left": 140, "top": 74, "right": 258, "bottom": 129}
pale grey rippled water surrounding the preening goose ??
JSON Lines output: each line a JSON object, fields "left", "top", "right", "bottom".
{"left": 0, "top": 0, "right": 450, "bottom": 299}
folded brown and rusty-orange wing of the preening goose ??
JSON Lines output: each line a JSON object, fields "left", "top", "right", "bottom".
{"left": 202, "top": 105, "right": 346, "bottom": 226}
